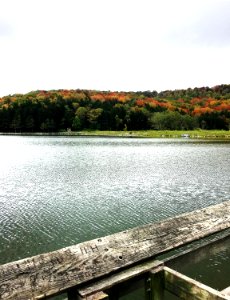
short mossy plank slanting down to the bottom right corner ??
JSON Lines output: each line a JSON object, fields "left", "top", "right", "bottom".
{"left": 164, "top": 267, "right": 229, "bottom": 300}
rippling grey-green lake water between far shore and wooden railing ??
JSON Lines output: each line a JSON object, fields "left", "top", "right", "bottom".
{"left": 0, "top": 136, "right": 230, "bottom": 292}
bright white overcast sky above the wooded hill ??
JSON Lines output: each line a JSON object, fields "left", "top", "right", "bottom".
{"left": 0, "top": 0, "right": 230, "bottom": 96}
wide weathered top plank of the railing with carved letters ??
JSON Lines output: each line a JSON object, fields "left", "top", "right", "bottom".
{"left": 0, "top": 201, "right": 230, "bottom": 300}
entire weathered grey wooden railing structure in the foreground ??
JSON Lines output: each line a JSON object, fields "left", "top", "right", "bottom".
{"left": 0, "top": 201, "right": 230, "bottom": 300}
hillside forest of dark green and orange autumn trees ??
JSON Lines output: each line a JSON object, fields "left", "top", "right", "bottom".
{"left": 0, "top": 85, "right": 230, "bottom": 132}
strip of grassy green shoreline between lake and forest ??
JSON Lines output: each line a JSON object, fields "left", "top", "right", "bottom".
{"left": 0, "top": 129, "right": 230, "bottom": 140}
